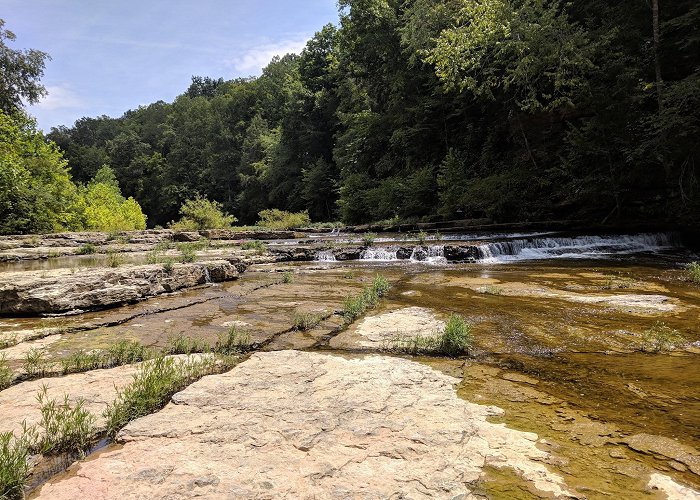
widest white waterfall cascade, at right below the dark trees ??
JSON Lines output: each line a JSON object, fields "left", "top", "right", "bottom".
{"left": 478, "top": 233, "right": 679, "bottom": 263}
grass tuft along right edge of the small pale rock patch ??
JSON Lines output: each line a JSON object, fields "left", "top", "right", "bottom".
{"left": 390, "top": 314, "right": 472, "bottom": 358}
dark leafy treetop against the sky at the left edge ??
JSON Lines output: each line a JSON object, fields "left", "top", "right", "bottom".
{"left": 0, "top": 19, "right": 50, "bottom": 114}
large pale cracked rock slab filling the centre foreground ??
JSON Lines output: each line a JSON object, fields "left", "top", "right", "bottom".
{"left": 37, "top": 351, "right": 576, "bottom": 500}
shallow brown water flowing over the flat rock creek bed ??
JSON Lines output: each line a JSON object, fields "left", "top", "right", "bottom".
{"left": 0, "top": 254, "right": 700, "bottom": 498}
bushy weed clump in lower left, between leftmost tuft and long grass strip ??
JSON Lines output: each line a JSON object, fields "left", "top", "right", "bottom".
{"left": 31, "top": 386, "right": 95, "bottom": 454}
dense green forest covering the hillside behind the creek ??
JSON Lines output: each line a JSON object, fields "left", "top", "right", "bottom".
{"left": 0, "top": 0, "right": 700, "bottom": 232}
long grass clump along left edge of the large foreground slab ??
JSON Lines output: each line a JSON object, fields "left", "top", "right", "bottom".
{"left": 104, "top": 356, "right": 232, "bottom": 437}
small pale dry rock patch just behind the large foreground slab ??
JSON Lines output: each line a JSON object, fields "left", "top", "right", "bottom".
{"left": 331, "top": 307, "right": 445, "bottom": 349}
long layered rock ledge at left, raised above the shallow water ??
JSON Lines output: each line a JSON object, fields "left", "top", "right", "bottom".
{"left": 0, "top": 261, "right": 238, "bottom": 314}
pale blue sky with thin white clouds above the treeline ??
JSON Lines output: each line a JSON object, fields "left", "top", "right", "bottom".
{"left": 0, "top": 0, "right": 338, "bottom": 132}
